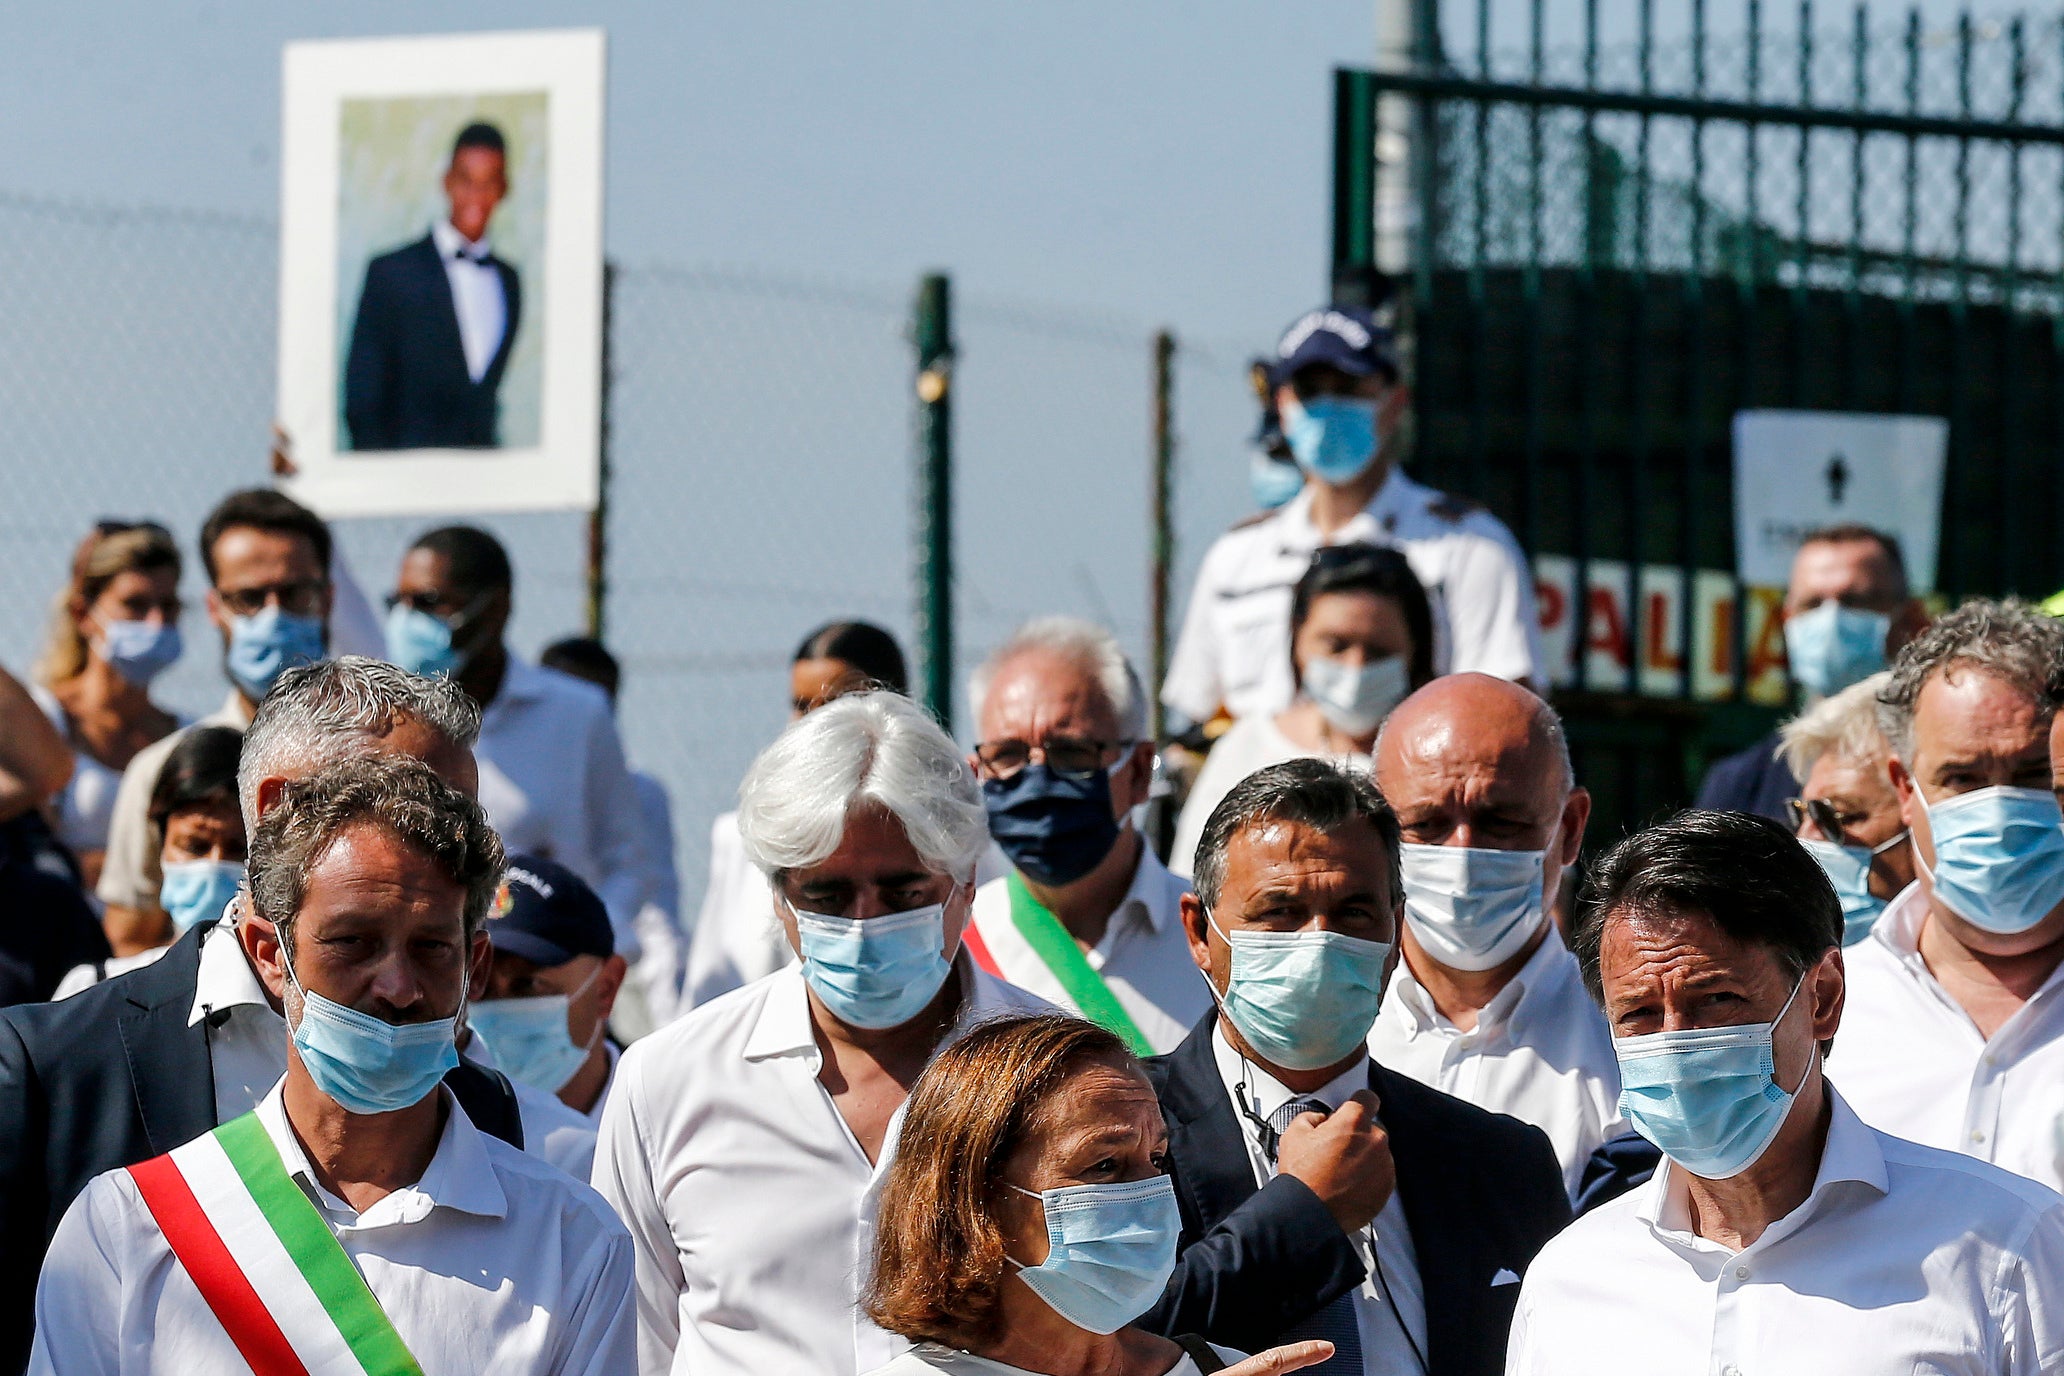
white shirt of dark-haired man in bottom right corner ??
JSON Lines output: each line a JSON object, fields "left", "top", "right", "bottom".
{"left": 1505, "top": 1093, "right": 2064, "bottom": 1376}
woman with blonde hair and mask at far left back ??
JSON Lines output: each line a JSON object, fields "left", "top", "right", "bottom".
{"left": 31, "top": 520, "right": 180, "bottom": 893}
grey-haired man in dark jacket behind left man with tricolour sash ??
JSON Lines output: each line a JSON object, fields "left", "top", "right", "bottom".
{"left": 0, "top": 656, "right": 522, "bottom": 1372}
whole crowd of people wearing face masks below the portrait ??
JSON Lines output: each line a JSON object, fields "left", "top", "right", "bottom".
{"left": 0, "top": 307, "right": 2064, "bottom": 1376}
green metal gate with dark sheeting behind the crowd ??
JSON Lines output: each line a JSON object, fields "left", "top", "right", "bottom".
{"left": 1333, "top": 0, "right": 2064, "bottom": 842}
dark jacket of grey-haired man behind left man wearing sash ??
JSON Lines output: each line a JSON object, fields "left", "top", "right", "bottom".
{"left": 0, "top": 922, "right": 522, "bottom": 1372}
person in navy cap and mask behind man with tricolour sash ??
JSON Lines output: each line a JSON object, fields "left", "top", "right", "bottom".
{"left": 469, "top": 854, "right": 625, "bottom": 1141}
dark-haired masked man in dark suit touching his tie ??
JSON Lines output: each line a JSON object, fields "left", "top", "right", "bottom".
{"left": 1141, "top": 759, "right": 1569, "bottom": 1376}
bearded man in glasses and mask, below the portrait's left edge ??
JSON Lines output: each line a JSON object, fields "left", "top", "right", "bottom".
{"left": 95, "top": 487, "right": 332, "bottom": 955}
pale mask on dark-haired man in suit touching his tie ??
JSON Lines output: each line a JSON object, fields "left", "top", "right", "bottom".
{"left": 1207, "top": 914, "right": 1391, "bottom": 1071}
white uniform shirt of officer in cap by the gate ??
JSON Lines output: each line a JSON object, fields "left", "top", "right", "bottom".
{"left": 1160, "top": 468, "right": 1544, "bottom": 722}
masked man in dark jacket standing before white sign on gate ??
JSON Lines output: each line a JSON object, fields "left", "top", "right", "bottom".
{"left": 1699, "top": 524, "right": 1928, "bottom": 821}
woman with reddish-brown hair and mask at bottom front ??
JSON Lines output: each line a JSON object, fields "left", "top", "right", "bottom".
{"left": 867, "top": 1013, "right": 1333, "bottom": 1376}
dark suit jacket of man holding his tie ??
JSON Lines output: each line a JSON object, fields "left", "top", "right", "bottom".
{"left": 1139, "top": 1011, "right": 1569, "bottom": 1376}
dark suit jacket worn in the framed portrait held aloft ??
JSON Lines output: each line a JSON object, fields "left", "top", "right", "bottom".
{"left": 345, "top": 235, "right": 522, "bottom": 450}
